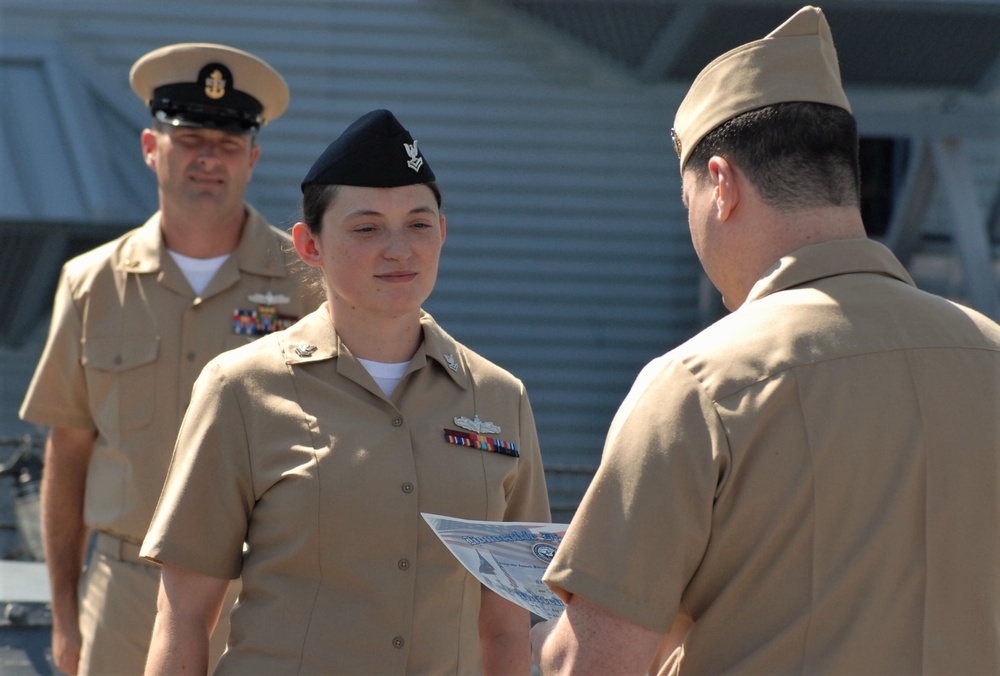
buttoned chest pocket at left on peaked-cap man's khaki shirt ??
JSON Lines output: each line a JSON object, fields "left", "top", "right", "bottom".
{"left": 83, "top": 337, "right": 160, "bottom": 430}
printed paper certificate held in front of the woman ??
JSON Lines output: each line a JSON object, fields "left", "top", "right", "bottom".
{"left": 421, "top": 512, "right": 567, "bottom": 620}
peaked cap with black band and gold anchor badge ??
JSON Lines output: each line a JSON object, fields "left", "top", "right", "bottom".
{"left": 129, "top": 42, "right": 289, "bottom": 134}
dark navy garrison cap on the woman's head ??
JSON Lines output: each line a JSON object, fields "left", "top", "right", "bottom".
{"left": 302, "top": 110, "right": 434, "bottom": 190}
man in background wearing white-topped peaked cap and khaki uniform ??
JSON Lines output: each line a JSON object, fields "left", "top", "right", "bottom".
{"left": 21, "top": 43, "right": 319, "bottom": 674}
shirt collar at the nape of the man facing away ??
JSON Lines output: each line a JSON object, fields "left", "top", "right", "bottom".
{"left": 746, "top": 239, "right": 916, "bottom": 303}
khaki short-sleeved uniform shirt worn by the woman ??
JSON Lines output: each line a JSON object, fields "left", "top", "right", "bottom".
{"left": 142, "top": 305, "right": 549, "bottom": 674}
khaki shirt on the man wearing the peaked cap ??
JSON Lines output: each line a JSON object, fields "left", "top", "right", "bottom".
{"left": 21, "top": 207, "right": 318, "bottom": 542}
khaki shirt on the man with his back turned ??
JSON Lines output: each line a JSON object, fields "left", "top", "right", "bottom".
{"left": 544, "top": 240, "right": 1000, "bottom": 674}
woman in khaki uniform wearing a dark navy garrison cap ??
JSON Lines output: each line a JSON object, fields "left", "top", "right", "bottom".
{"left": 142, "top": 110, "right": 549, "bottom": 674}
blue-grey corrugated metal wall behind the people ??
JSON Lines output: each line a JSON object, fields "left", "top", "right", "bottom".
{"left": 0, "top": 0, "right": 700, "bottom": 492}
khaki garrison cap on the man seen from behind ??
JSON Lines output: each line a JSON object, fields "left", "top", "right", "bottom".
{"left": 670, "top": 6, "right": 851, "bottom": 171}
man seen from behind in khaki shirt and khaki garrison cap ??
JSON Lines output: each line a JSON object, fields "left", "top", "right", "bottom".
{"left": 532, "top": 7, "right": 1000, "bottom": 674}
